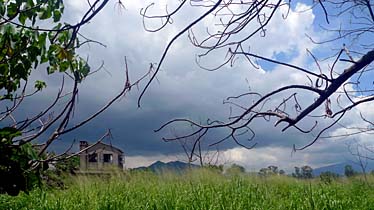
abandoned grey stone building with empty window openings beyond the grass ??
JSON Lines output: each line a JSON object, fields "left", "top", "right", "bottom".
{"left": 79, "top": 141, "right": 123, "bottom": 171}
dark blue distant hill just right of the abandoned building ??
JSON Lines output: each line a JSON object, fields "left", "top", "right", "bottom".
{"left": 132, "top": 161, "right": 199, "bottom": 173}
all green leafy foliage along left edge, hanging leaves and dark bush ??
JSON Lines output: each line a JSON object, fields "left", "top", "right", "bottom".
{"left": 0, "top": 0, "right": 90, "bottom": 195}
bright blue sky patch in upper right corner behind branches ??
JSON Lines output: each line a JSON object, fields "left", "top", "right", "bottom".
{"left": 292, "top": 0, "right": 374, "bottom": 96}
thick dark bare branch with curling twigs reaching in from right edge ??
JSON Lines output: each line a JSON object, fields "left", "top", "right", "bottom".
{"left": 156, "top": 46, "right": 374, "bottom": 150}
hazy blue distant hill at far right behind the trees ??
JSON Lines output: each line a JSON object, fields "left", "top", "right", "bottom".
{"left": 313, "top": 161, "right": 374, "bottom": 176}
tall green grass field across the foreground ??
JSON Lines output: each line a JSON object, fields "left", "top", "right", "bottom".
{"left": 0, "top": 170, "right": 374, "bottom": 210}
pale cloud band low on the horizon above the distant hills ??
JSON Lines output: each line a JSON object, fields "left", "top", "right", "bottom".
{"left": 125, "top": 141, "right": 352, "bottom": 174}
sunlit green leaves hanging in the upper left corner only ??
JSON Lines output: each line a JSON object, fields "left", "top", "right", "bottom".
{"left": 0, "top": 0, "right": 90, "bottom": 98}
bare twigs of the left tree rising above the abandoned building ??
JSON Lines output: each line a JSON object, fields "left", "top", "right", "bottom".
{"left": 2, "top": 57, "right": 150, "bottom": 162}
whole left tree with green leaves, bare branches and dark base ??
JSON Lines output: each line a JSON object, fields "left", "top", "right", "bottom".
{"left": 0, "top": 0, "right": 149, "bottom": 195}
